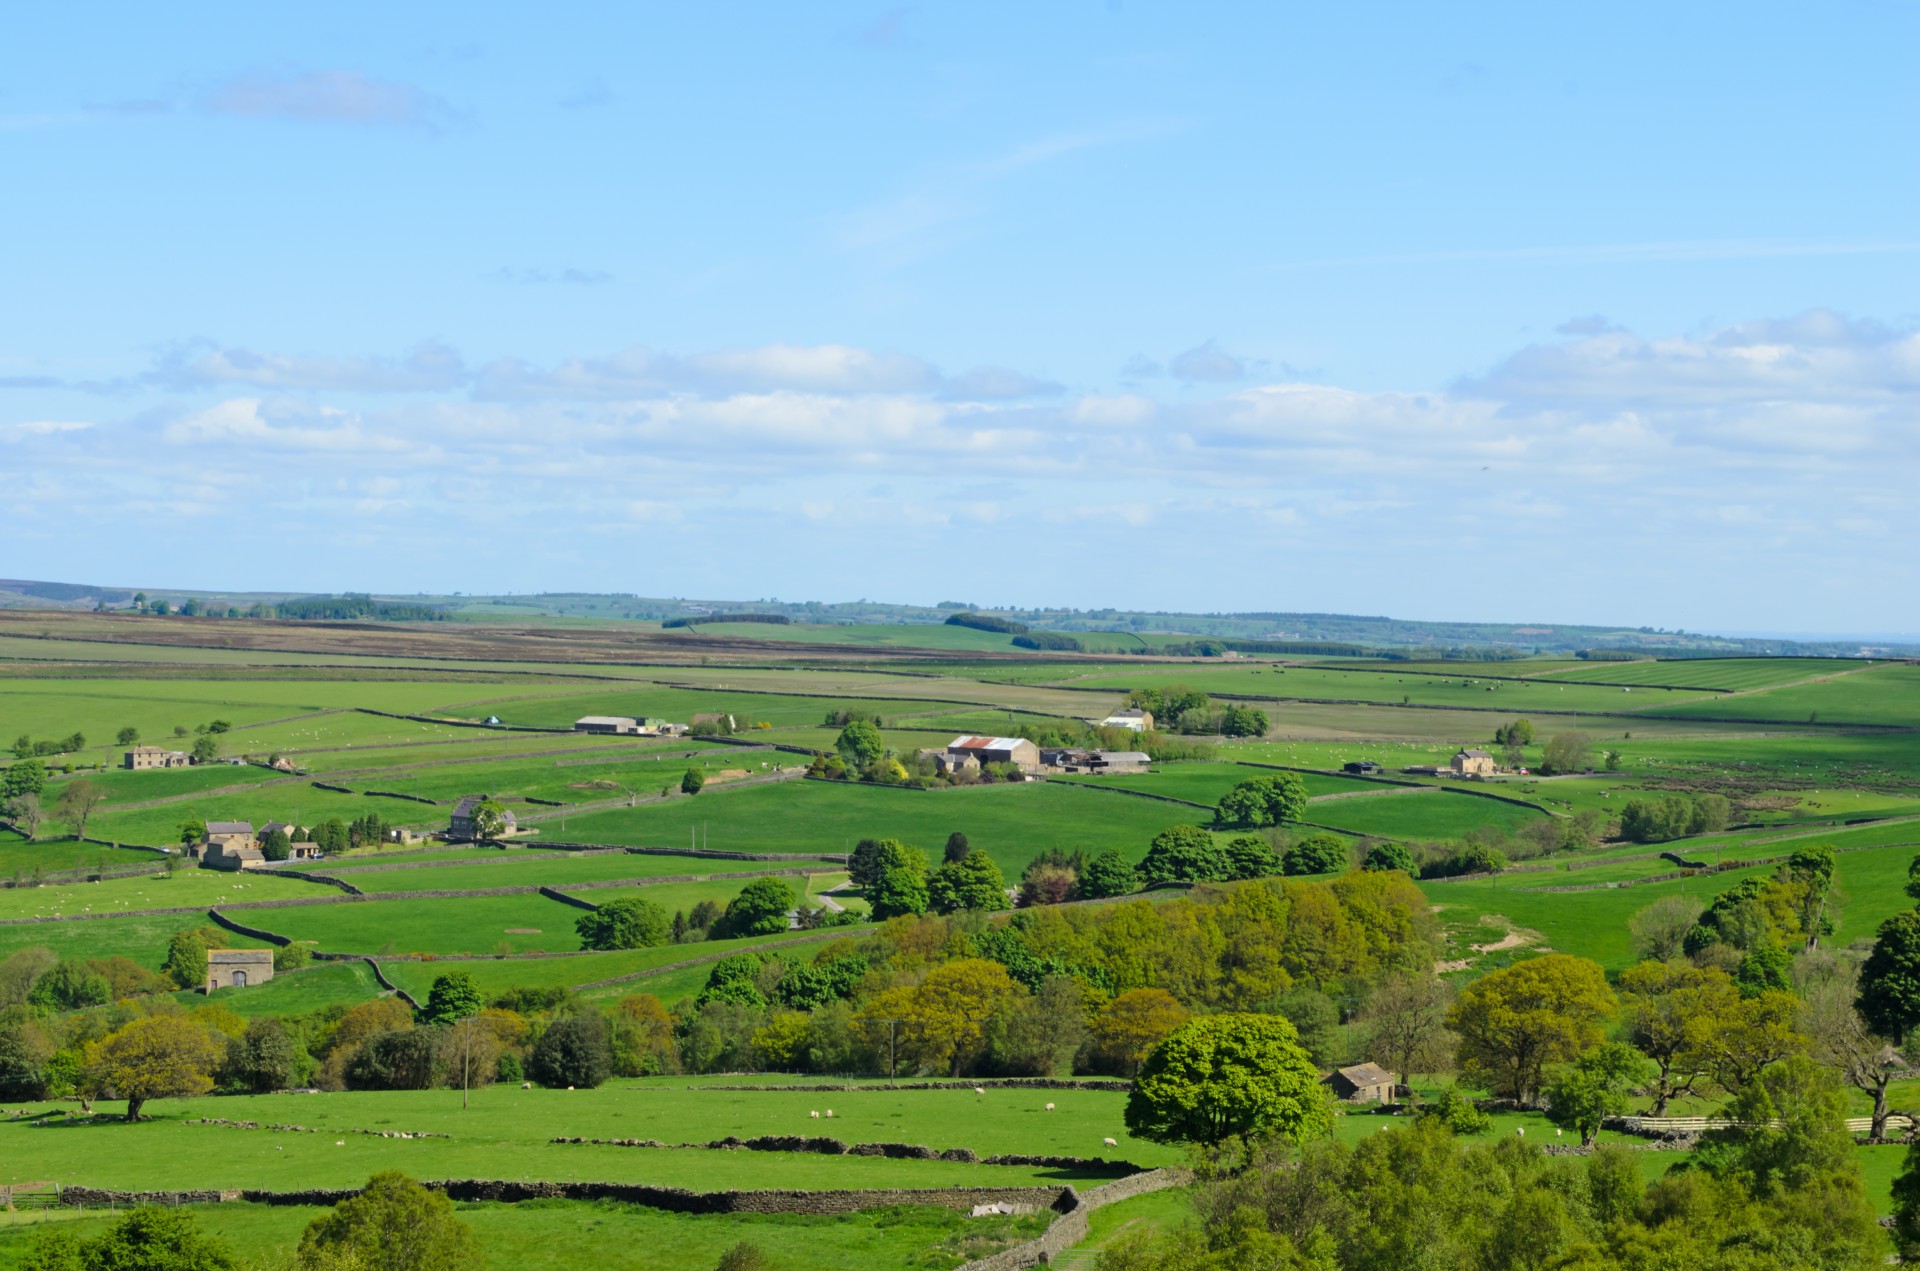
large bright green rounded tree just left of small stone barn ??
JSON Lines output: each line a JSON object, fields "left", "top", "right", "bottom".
{"left": 1127, "top": 1014, "right": 1332, "bottom": 1148}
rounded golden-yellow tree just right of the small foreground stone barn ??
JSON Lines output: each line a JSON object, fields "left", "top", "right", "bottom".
{"left": 1448, "top": 954, "right": 1619, "bottom": 1104}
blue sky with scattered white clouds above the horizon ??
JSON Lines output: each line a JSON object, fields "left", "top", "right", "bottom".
{"left": 0, "top": 0, "right": 1920, "bottom": 632}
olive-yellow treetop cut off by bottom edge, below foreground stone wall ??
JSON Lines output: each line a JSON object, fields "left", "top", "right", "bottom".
{"left": 296, "top": 1169, "right": 486, "bottom": 1271}
